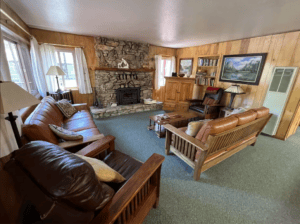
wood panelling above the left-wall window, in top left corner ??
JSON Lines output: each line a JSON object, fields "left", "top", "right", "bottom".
{"left": 0, "top": 0, "right": 30, "bottom": 41}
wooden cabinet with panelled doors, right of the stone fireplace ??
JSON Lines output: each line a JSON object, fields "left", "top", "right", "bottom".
{"left": 163, "top": 77, "right": 195, "bottom": 111}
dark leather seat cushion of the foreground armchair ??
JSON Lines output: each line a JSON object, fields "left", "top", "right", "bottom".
{"left": 103, "top": 150, "right": 143, "bottom": 192}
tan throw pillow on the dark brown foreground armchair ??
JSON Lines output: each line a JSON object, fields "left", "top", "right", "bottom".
{"left": 75, "top": 154, "right": 126, "bottom": 183}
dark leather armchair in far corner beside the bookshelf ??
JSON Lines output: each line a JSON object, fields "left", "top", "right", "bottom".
{"left": 189, "top": 87, "right": 224, "bottom": 119}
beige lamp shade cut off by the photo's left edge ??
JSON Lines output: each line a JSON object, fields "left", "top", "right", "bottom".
{"left": 0, "top": 82, "right": 40, "bottom": 114}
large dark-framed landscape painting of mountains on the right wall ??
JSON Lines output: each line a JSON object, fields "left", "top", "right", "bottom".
{"left": 220, "top": 53, "right": 267, "bottom": 85}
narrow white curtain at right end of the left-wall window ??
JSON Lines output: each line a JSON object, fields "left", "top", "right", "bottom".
{"left": 30, "top": 37, "right": 48, "bottom": 97}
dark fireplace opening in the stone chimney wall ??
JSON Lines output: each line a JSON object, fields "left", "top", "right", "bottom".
{"left": 116, "top": 87, "right": 141, "bottom": 105}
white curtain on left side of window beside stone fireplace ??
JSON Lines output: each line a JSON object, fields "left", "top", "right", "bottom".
{"left": 40, "top": 44, "right": 58, "bottom": 92}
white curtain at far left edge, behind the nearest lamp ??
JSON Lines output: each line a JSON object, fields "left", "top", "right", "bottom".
{"left": 0, "top": 29, "right": 22, "bottom": 157}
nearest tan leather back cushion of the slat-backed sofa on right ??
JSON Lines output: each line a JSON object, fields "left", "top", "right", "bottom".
{"left": 195, "top": 116, "right": 239, "bottom": 143}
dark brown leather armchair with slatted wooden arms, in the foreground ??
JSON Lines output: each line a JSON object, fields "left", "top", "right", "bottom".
{"left": 0, "top": 136, "right": 164, "bottom": 224}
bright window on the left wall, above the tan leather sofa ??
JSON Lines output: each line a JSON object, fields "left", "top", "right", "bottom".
{"left": 4, "top": 38, "right": 37, "bottom": 94}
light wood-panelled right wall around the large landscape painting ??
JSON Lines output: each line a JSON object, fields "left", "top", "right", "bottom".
{"left": 177, "top": 31, "right": 300, "bottom": 139}
